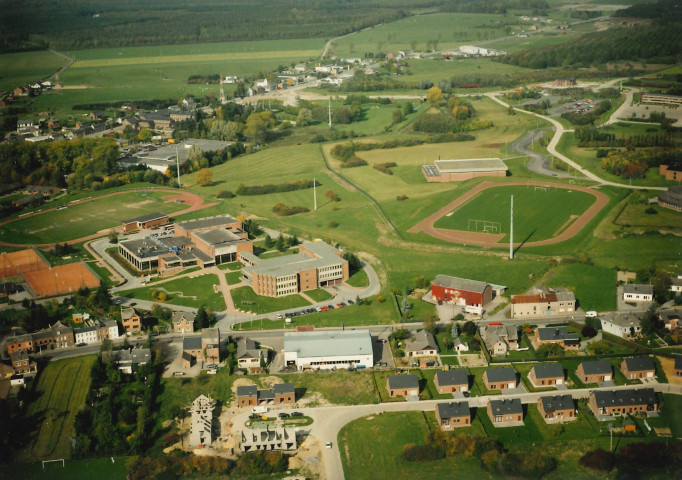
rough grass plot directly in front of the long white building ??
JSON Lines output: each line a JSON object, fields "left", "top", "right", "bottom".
{"left": 278, "top": 370, "right": 379, "bottom": 405}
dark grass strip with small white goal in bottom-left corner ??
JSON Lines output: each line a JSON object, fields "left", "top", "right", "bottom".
{"left": 0, "top": 457, "right": 128, "bottom": 480}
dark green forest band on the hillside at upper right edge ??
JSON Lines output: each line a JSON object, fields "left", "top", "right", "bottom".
{"left": 499, "top": 23, "right": 682, "bottom": 69}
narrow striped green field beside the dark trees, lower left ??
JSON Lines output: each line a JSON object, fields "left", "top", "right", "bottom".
{"left": 20, "top": 356, "right": 95, "bottom": 461}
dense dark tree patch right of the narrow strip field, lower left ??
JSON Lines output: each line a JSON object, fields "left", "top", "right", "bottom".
{"left": 74, "top": 340, "right": 163, "bottom": 457}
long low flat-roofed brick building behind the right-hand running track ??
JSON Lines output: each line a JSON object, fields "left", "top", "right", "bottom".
{"left": 422, "top": 158, "right": 508, "bottom": 182}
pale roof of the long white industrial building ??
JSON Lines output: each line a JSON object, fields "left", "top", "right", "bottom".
{"left": 284, "top": 330, "right": 373, "bottom": 358}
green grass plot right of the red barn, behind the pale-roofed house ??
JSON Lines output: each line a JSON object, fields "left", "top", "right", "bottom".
{"left": 547, "top": 263, "right": 616, "bottom": 312}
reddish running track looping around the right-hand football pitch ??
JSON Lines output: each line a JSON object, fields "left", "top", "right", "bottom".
{"left": 408, "top": 182, "right": 609, "bottom": 248}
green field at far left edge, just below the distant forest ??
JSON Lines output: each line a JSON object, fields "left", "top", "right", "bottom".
{"left": 0, "top": 51, "right": 68, "bottom": 92}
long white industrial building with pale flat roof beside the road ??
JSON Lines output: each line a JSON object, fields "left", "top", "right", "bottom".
{"left": 284, "top": 330, "right": 374, "bottom": 370}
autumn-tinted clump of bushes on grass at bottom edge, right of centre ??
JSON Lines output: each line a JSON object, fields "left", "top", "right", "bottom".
{"left": 400, "top": 428, "right": 556, "bottom": 478}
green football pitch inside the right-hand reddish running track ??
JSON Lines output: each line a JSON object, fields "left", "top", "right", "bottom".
{"left": 435, "top": 186, "right": 595, "bottom": 242}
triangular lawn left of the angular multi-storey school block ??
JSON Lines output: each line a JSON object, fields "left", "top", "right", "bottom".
{"left": 119, "top": 273, "right": 223, "bottom": 312}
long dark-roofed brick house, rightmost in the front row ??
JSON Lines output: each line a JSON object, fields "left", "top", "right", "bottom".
{"left": 587, "top": 388, "right": 658, "bottom": 420}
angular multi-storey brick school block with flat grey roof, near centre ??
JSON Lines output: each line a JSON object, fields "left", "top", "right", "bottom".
{"left": 239, "top": 242, "right": 349, "bottom": 297}
